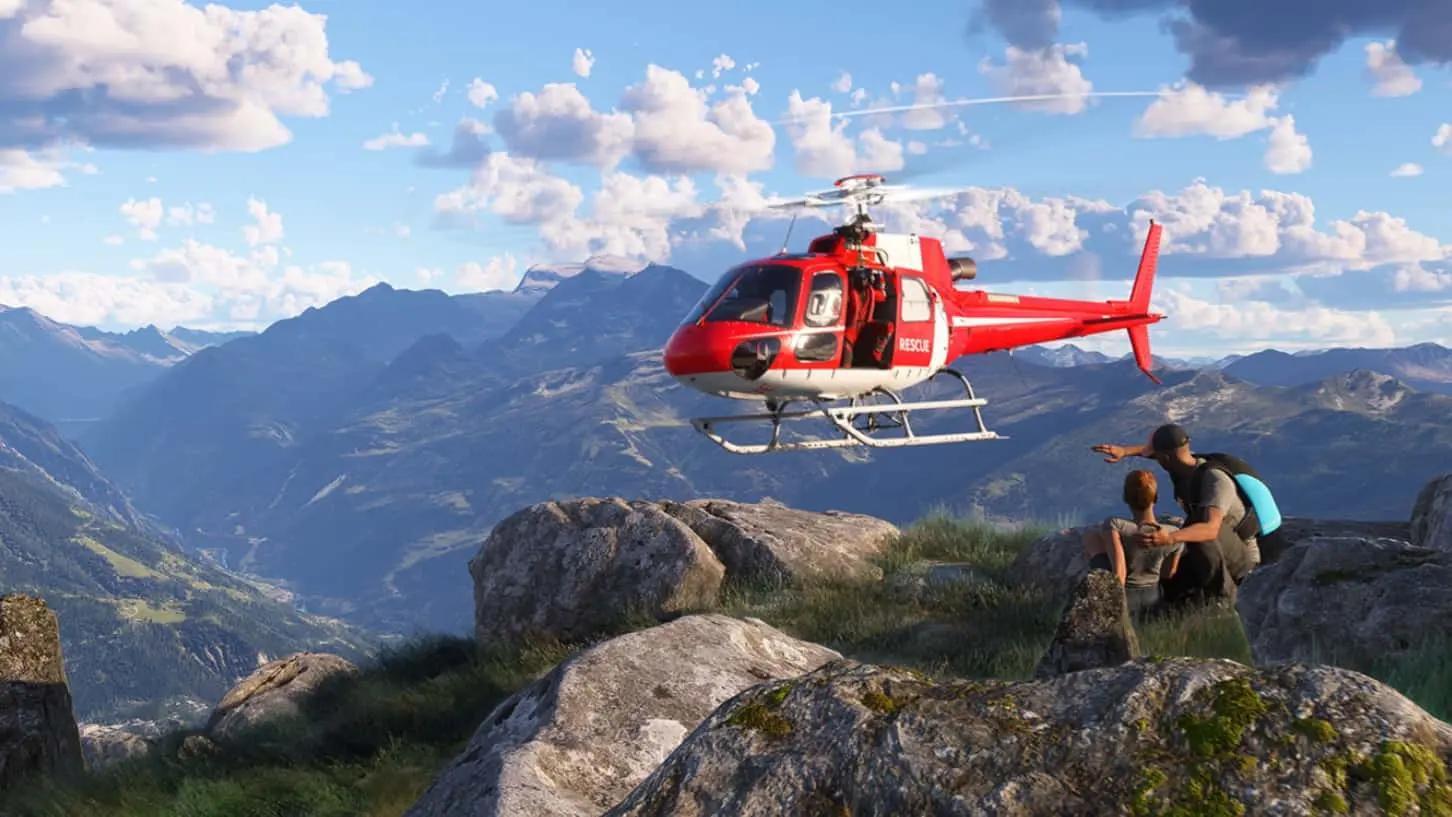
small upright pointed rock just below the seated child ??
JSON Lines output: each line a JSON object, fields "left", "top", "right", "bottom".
{"left": 1034, "top": 570, "right": 1140, "bottom": 678}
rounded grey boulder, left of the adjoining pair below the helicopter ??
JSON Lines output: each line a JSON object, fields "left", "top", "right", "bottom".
{"left": 469, "top": 498, "right": 726, "bottom": 644}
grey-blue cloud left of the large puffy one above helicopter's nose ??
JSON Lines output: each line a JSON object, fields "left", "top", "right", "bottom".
{"left": 494, "top": 83, "right": 635, "bottom": 167}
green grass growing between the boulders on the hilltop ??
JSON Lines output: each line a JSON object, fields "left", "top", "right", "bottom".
{"left": 0, "top": 514, "right": 1452, "bottom": 817}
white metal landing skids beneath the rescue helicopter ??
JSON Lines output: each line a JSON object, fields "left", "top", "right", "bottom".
{"left": 691, "top": 369, "right": 1006, "bottom": 454}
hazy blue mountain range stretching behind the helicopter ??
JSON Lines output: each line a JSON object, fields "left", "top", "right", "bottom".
{"left": 0, "top": 261, "right": 1452, "bottom": 641}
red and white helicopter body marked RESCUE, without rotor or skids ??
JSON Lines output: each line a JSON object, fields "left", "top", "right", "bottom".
{"left": 665, "top": 222, "right": 1163, "bottom": 402}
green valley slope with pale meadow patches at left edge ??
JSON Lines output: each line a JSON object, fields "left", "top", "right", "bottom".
{"left": 0, "top": 403, "right": 373, "bottom": 720}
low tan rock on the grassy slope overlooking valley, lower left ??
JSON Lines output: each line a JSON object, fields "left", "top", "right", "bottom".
{"left": 205, "top": 653, "right": 357, "bottom": 742}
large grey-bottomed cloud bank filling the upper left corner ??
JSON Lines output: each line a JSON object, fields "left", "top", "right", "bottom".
{"left": 0, "top": 0, "right": 373, "bottom": 151}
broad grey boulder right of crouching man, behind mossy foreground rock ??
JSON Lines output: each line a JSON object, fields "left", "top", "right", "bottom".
{"left": 1236, "top": 537, "right": 1452, "bottom": 668}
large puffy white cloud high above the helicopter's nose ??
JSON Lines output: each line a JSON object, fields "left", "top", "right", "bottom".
{"left": 620, "top": 64, "right": 777, "bottom": 174}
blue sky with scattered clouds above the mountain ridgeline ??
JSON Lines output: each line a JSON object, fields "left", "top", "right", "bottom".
{"left": 0, "top": 0, "right": 1452, "bottom": 354}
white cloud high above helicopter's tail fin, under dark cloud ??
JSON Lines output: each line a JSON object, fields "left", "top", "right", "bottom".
{"left": 1133, "top": 80, "right": 1311, "bottom": 174}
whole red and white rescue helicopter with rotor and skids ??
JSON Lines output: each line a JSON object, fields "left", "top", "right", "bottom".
{"left": 664, "top": 174, "right": 1165, "bottom": 454}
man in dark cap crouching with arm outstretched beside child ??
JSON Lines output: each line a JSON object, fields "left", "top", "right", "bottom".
{"left": 1093, "top": 424, "right": 1260, "bottom": 598}
